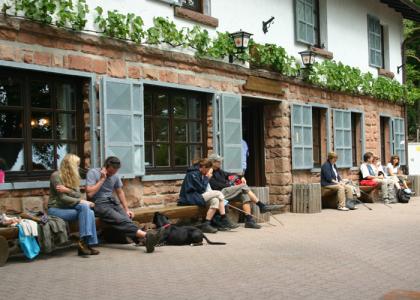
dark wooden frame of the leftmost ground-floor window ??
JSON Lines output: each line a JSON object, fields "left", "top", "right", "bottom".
{"left": 0, "top": 64, "right": 85, "bottom": 182}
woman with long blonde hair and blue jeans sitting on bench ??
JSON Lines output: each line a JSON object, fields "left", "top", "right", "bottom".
{"left": 48, "top": 154, "right": 99, "bottom": 255}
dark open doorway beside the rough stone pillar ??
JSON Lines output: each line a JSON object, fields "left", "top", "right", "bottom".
{"left": 242, "top": 98, "right": 266, "bottom": 186}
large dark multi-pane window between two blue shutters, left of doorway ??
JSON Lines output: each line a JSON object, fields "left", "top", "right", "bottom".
{"left": 144, "top": 87, "right": 207, "bottom": 172}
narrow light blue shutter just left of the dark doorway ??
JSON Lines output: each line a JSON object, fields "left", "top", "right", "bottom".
{"left": 219, "top": 94, "right": 242, "bottom": 173}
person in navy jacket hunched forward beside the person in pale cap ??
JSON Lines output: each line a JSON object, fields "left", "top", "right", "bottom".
{"left": 178, "top": 159, "right": 230, "bottom": 233}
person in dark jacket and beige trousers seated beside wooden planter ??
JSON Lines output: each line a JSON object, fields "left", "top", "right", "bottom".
{"left": 321, "top": 152, "right": 357, "bottom": 211}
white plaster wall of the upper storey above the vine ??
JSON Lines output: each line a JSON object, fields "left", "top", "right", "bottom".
{"left": 0, "top": 0, "right": 403, "bottom": 80}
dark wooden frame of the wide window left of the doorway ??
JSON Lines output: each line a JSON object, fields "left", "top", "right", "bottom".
{"left": 144, "top": 84, "right": 209, "bottom": 175}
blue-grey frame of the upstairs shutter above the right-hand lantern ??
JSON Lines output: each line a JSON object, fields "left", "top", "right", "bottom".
{"left": 294, "top": 0, "right": 322, "bottom": 48}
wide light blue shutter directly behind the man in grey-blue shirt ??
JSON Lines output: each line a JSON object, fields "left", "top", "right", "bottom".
{"left": 101, "top": 77, "right": 144, "bottom": 178}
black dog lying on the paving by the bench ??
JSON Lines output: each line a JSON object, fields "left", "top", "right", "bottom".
{"left": 153, "top": 212, "right": 226, "bottom": 246}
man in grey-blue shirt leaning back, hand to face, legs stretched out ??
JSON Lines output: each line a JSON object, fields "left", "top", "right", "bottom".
{"left": 86, "top": 156, "right": 160, "bottom": 253}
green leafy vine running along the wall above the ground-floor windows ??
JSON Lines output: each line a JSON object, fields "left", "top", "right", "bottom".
{"left": 1, "top": 0, "right": 420, "bottom": 103}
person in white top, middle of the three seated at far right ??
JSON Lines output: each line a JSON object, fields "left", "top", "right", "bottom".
{"left": 359, "top": 152, "right": 396, "bottom": 204}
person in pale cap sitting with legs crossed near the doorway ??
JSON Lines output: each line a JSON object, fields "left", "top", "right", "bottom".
{"left": 208, "top": 153, "right": 279, "bottom": 229}
